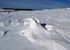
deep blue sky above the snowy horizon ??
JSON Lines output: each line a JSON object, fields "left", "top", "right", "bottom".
{"left": 0, "top": 0, "right": 70, "bottom": 9}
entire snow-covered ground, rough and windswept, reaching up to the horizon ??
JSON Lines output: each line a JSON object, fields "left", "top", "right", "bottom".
{"left": 0, "top": 8, "right": 70, "bottom": 50}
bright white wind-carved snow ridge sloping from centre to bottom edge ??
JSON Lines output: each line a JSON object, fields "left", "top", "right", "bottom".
{"left": 20, "top": 18, "right": 68, "bottom": 50}
